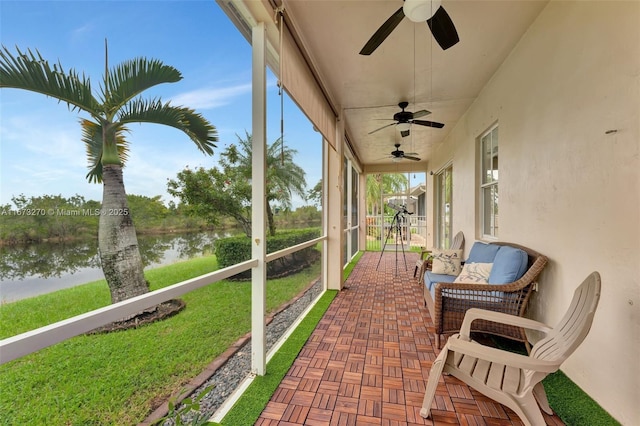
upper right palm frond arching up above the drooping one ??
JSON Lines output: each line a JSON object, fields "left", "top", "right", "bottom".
{"left": 100, "top": 58, "right": 182, "bottom": 115}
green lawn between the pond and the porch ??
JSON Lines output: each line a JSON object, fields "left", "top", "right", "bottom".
{"left": 0, "top": 256, "right": 320, "bottom": 425}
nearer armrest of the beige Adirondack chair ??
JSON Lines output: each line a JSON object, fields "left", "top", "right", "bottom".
{"left": 445, "top": 335, "right": 560, "bottom": 373}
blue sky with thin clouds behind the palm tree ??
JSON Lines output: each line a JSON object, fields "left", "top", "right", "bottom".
{"left": 0, "top": 0, "right": 322, "bottom": 205}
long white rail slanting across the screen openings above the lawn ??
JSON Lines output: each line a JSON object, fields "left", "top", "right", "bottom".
{"left": 0, "top": 237, "right": 326, "bottom": 365}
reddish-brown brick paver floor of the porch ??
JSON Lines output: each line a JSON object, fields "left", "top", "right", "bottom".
{"left": 256, "top": 251, "right": 563, "bottom": 426}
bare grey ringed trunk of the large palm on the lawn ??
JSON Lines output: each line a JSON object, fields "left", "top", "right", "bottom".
{"left": 98, "top": 164, "right": 149, "bottom": 303}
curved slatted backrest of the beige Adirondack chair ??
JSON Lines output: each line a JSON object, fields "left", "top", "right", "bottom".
{"left": 531, "top": 272, "right": 601, "bottom": 364}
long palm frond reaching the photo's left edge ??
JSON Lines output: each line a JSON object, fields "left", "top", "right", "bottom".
{"left": 0, "top": 45, "right": 100, "bottom": 116}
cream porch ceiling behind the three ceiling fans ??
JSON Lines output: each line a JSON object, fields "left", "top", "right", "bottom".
{"left": 228, "top": 0, "right": 547, "bottom": 170}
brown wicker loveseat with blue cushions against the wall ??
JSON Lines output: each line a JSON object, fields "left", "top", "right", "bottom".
{"left": 424, "top": 242, "right": 547, "bottom": 351}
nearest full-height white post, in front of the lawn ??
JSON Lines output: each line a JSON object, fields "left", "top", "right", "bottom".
{"left": 251, "top": 22, "right": 267, "bottom": 376}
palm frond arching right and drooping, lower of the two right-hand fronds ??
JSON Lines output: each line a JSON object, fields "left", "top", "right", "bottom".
{"left": 118, "top": 99, "right": 218, "bottom": 155}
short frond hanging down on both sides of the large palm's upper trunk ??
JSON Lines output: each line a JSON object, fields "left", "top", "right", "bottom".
{"left": 80, "top": 119, "right": 129, "bottom": 183}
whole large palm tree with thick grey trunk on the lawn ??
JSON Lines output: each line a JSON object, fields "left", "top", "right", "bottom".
{"left": 0, "top": 42, "right": 218, "bottom": 303}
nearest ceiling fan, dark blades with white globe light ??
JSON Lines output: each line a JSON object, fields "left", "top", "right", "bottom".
{"left": 360, "top": 0, "right": 460, "bottom": 55}
